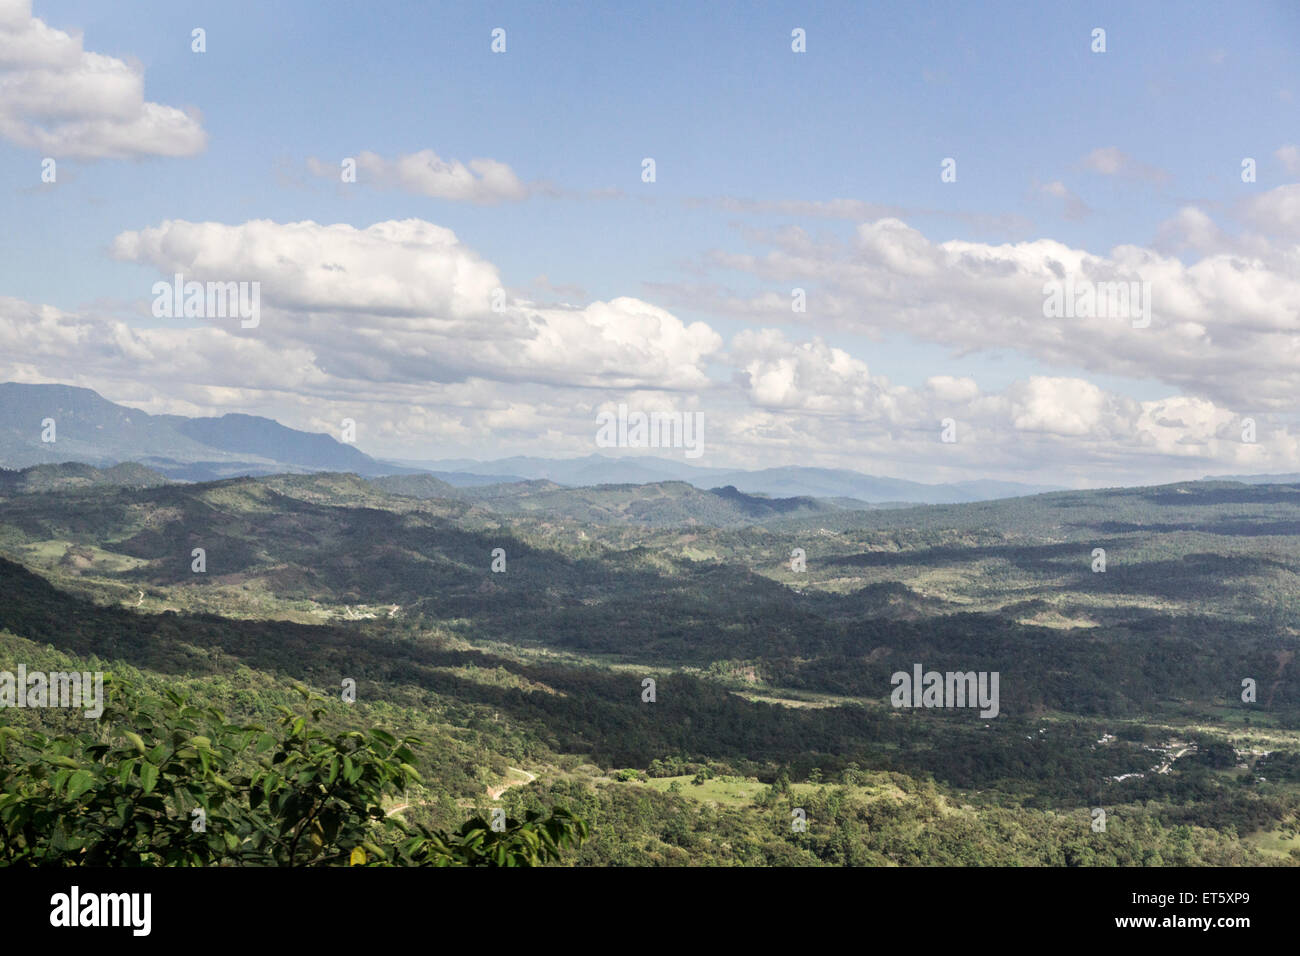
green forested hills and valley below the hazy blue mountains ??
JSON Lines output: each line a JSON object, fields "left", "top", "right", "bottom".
{"left": 0, "top": 467, "right": 1300, "bottom": 865}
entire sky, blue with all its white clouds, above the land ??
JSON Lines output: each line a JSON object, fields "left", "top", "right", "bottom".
{"left": 0, "top": 0, "right": 1300, "bottom": 486}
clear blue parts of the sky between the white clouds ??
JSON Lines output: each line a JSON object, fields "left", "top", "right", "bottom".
{"left": 0, "top": 0, "right": 1300, "bottom": 481}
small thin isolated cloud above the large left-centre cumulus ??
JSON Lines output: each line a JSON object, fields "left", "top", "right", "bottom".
{"left": 307, "top": 150, "right": 529, "bottom": 204}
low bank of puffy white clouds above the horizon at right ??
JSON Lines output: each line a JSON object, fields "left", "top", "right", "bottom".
{"left": 710, "top": 329, "right": 1300, "bottom": 484}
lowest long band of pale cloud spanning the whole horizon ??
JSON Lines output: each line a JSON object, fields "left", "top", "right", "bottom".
{"left": 0, "top": 298, "right": 1300, "bottom": 485}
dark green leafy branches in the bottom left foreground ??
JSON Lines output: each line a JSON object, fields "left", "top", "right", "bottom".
{"left": 0, "top": 676, "right": 588, "bottom": 866}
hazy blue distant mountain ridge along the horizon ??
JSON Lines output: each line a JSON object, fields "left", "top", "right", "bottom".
{"left": 0, "top": 382, "right": 1062, "bottom": 507}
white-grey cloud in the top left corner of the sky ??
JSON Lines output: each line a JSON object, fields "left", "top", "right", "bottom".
{"left": 0, "top": 0, "right": 207, "bottom": 159}
